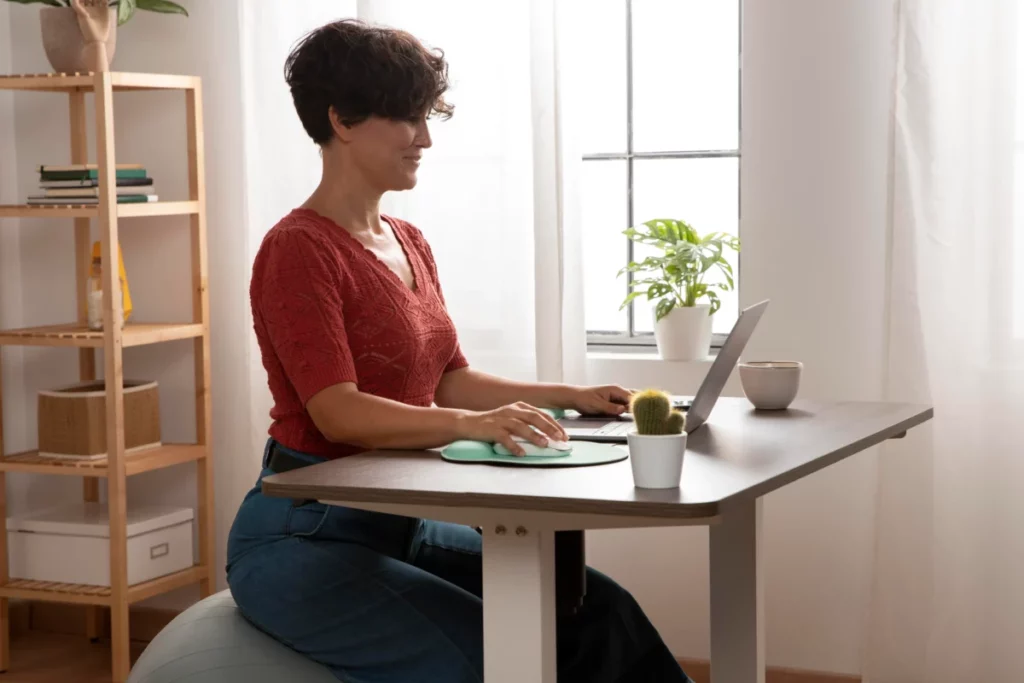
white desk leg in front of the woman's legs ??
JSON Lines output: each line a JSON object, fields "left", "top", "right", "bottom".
{"left": 483, "top": 525, "right": 557, "bottom": 683}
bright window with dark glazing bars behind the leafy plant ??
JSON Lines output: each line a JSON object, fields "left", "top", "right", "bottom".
{"left": 580, "top": 0, "right": 740, "bottom": 345}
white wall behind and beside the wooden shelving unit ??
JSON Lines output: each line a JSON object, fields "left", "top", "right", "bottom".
{"left": 0, "top": 0, "right": 261, "bottom": 606}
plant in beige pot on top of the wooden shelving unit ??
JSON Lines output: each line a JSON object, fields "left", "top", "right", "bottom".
{"left": 7, "top": 0, "right": 188, "bottom": 74}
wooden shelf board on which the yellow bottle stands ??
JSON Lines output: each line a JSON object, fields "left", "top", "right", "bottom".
{"left": 0, "top": 323, "right": 203, "bottom": 348}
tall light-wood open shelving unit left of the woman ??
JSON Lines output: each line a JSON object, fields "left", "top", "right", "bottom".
{"left": 0, "top": 72, "right": 216, "bottom": 683}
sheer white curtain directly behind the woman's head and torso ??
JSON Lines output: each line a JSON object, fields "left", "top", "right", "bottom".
{"left": 234, "top": 0, "right": 586, "bottom": 413}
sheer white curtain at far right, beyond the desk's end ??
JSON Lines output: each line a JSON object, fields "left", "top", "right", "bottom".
{"left": 864, "top": 0, "right": 1024, "bottom": 683}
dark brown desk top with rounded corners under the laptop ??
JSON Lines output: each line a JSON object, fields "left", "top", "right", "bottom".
{"left": 263, "top": 397, "right": 933, "bottom": 518}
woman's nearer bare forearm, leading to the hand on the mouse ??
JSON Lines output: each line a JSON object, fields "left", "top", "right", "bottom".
{"left": 306, "top": 385, "right": 466, "bottom": 449}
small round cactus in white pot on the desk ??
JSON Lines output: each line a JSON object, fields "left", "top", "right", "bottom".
{"left": 627, "top": 389, "right": 686, "bottom": 488}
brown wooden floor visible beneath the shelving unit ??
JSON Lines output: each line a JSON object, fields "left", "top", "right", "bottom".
{"left": 0, "top": 631, "right": 145, "bottom": 683}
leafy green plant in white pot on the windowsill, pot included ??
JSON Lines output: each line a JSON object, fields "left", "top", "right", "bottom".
{"left": 618, "top": 218, "right": 739, "bottom": 360}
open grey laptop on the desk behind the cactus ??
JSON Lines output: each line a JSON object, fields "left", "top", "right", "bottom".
{"left": 558, "top": 300, "right": 768, "bottom": 443}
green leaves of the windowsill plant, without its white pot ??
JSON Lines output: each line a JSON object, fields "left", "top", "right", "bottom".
{"left": 618, "top": 218, "right": 739, "bottom": 321}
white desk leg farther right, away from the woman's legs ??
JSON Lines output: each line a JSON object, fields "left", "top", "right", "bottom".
{"left": 710, "top": 499, "right": 765, "bottom": 683}
